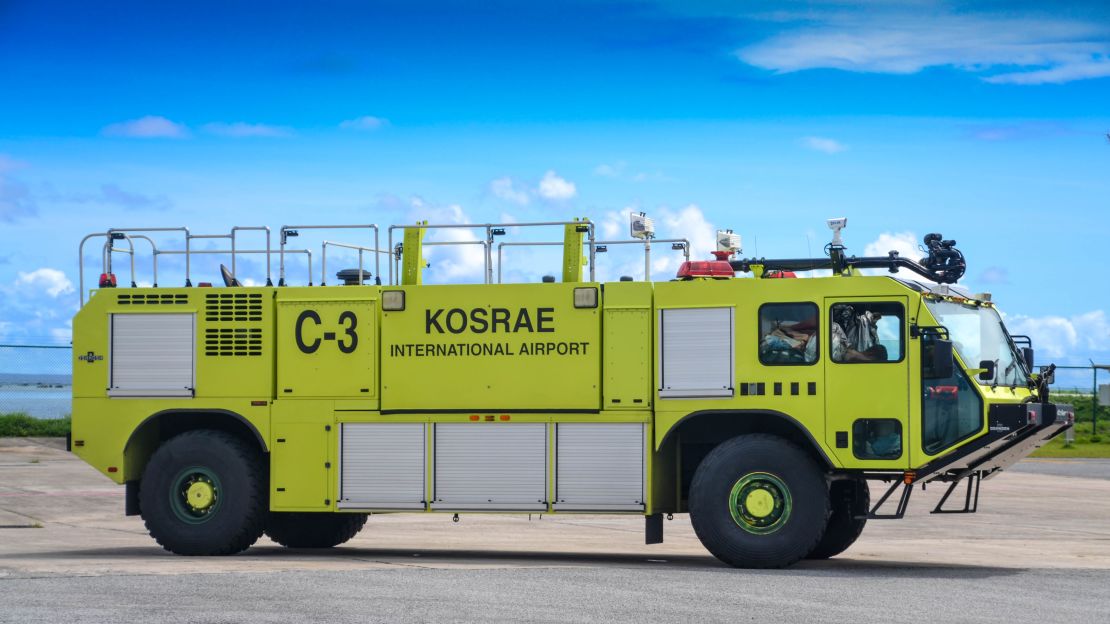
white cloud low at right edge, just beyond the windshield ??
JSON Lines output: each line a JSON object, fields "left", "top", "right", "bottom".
{"left": 1006, "top": 310, "right": 1110, "bottom": 361}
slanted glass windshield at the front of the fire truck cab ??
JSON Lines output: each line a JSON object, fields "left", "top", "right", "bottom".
{"left": 926, "top": 300, "right": 1029, "bottom": 385}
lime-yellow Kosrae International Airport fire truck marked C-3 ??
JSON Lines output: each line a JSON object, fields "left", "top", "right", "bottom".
{"left": 71, "top": 214, "right": 1073, "bottom": 567}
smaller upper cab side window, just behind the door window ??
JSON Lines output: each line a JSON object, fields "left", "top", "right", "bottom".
{"left": 759, "top": 303, "right": 820, "bottom": 365}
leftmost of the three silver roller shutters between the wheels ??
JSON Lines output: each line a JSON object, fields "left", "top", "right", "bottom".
{"left": 339, "top": 423, "right": 426, "bottom": 510}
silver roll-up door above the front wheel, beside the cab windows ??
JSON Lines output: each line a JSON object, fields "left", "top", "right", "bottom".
{"left": 659, "top": 308, "right": 735, "bottom": 397}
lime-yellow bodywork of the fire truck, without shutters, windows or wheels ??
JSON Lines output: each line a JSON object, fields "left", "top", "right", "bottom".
{"left": 73, "top": 269, "right": 1029, "bottom": 513}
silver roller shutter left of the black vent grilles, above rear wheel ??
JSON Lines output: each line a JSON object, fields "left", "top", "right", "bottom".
{"left": 108, "top": 314, "right": 196, "bottom": 396}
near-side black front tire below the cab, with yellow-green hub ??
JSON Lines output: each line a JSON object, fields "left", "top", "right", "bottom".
{"left": 689, "top": 434, "right": 829, "bottom": 567}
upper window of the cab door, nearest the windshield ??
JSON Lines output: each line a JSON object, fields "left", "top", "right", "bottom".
{"left": 829, "top": 303, "right": 906, "bottom": 364}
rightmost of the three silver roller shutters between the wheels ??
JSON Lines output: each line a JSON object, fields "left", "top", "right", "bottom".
{"left": 555, "top": 423, "right": 644, "bottom": 511}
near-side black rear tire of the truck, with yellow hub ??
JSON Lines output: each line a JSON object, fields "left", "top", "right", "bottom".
{"left": 139, "top": 430, "right": 268, "bottom": 555}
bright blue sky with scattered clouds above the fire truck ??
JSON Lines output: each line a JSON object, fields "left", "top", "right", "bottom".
{"left": 0, "top": 0, "right": 1110, "bottom": 384}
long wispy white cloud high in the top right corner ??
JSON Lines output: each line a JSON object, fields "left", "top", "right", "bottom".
{"left": 736, "top": 10, "right": 1110, "bottom": 84}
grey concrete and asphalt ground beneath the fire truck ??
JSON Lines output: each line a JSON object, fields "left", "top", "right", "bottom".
{"left": 0, "top": 440, "right": 1110, "bottom": 624}
